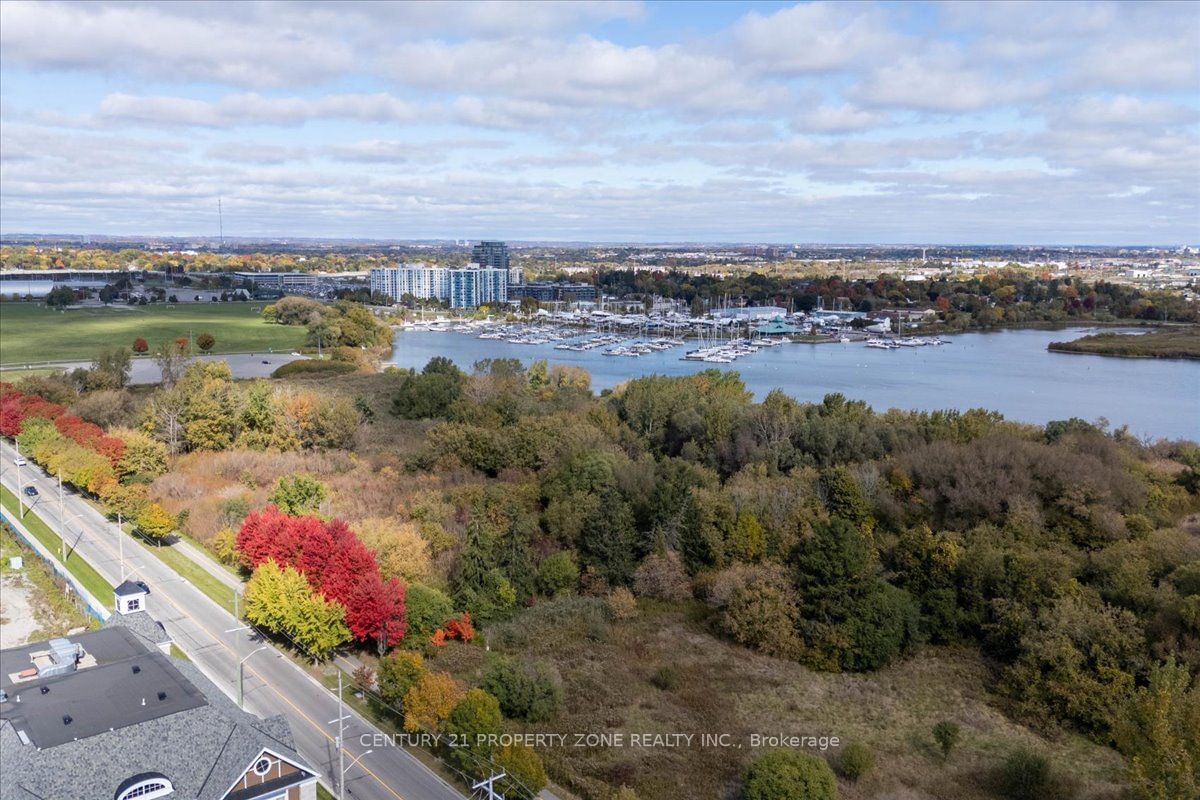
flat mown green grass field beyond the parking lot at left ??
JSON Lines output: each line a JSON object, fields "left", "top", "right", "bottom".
{"left": 0, "top": 302, "right": 307, "bottom": 365}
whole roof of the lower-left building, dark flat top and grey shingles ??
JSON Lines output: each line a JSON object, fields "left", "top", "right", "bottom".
{"left": 0, "top": 620, "right": 316, "bottom": 800}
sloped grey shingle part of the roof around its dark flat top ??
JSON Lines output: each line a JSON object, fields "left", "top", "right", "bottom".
{"left": 0, "top": 627, "right": 316, "bottom": 800}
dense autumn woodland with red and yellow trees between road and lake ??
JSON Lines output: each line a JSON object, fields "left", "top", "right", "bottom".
{"left": 2, "top": 350, "right": 1200, "bottom": 800}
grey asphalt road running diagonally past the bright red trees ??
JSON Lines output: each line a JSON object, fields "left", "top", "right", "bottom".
{"left": 0, "top": 441, "right": 463, "bottom": 800}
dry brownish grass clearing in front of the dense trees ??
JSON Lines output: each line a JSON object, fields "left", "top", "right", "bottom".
{"left": 433, "top": 597, "right": 1122, "bottom": 800}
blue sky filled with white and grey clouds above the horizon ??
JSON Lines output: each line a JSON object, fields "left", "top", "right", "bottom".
{"left": 0, "top": 0, "right": 1200, "bottom": 245}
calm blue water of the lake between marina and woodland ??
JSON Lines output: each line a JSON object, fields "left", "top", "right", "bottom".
{"left": 391, "top": 327, "right": 1200, "bottom": 440}
